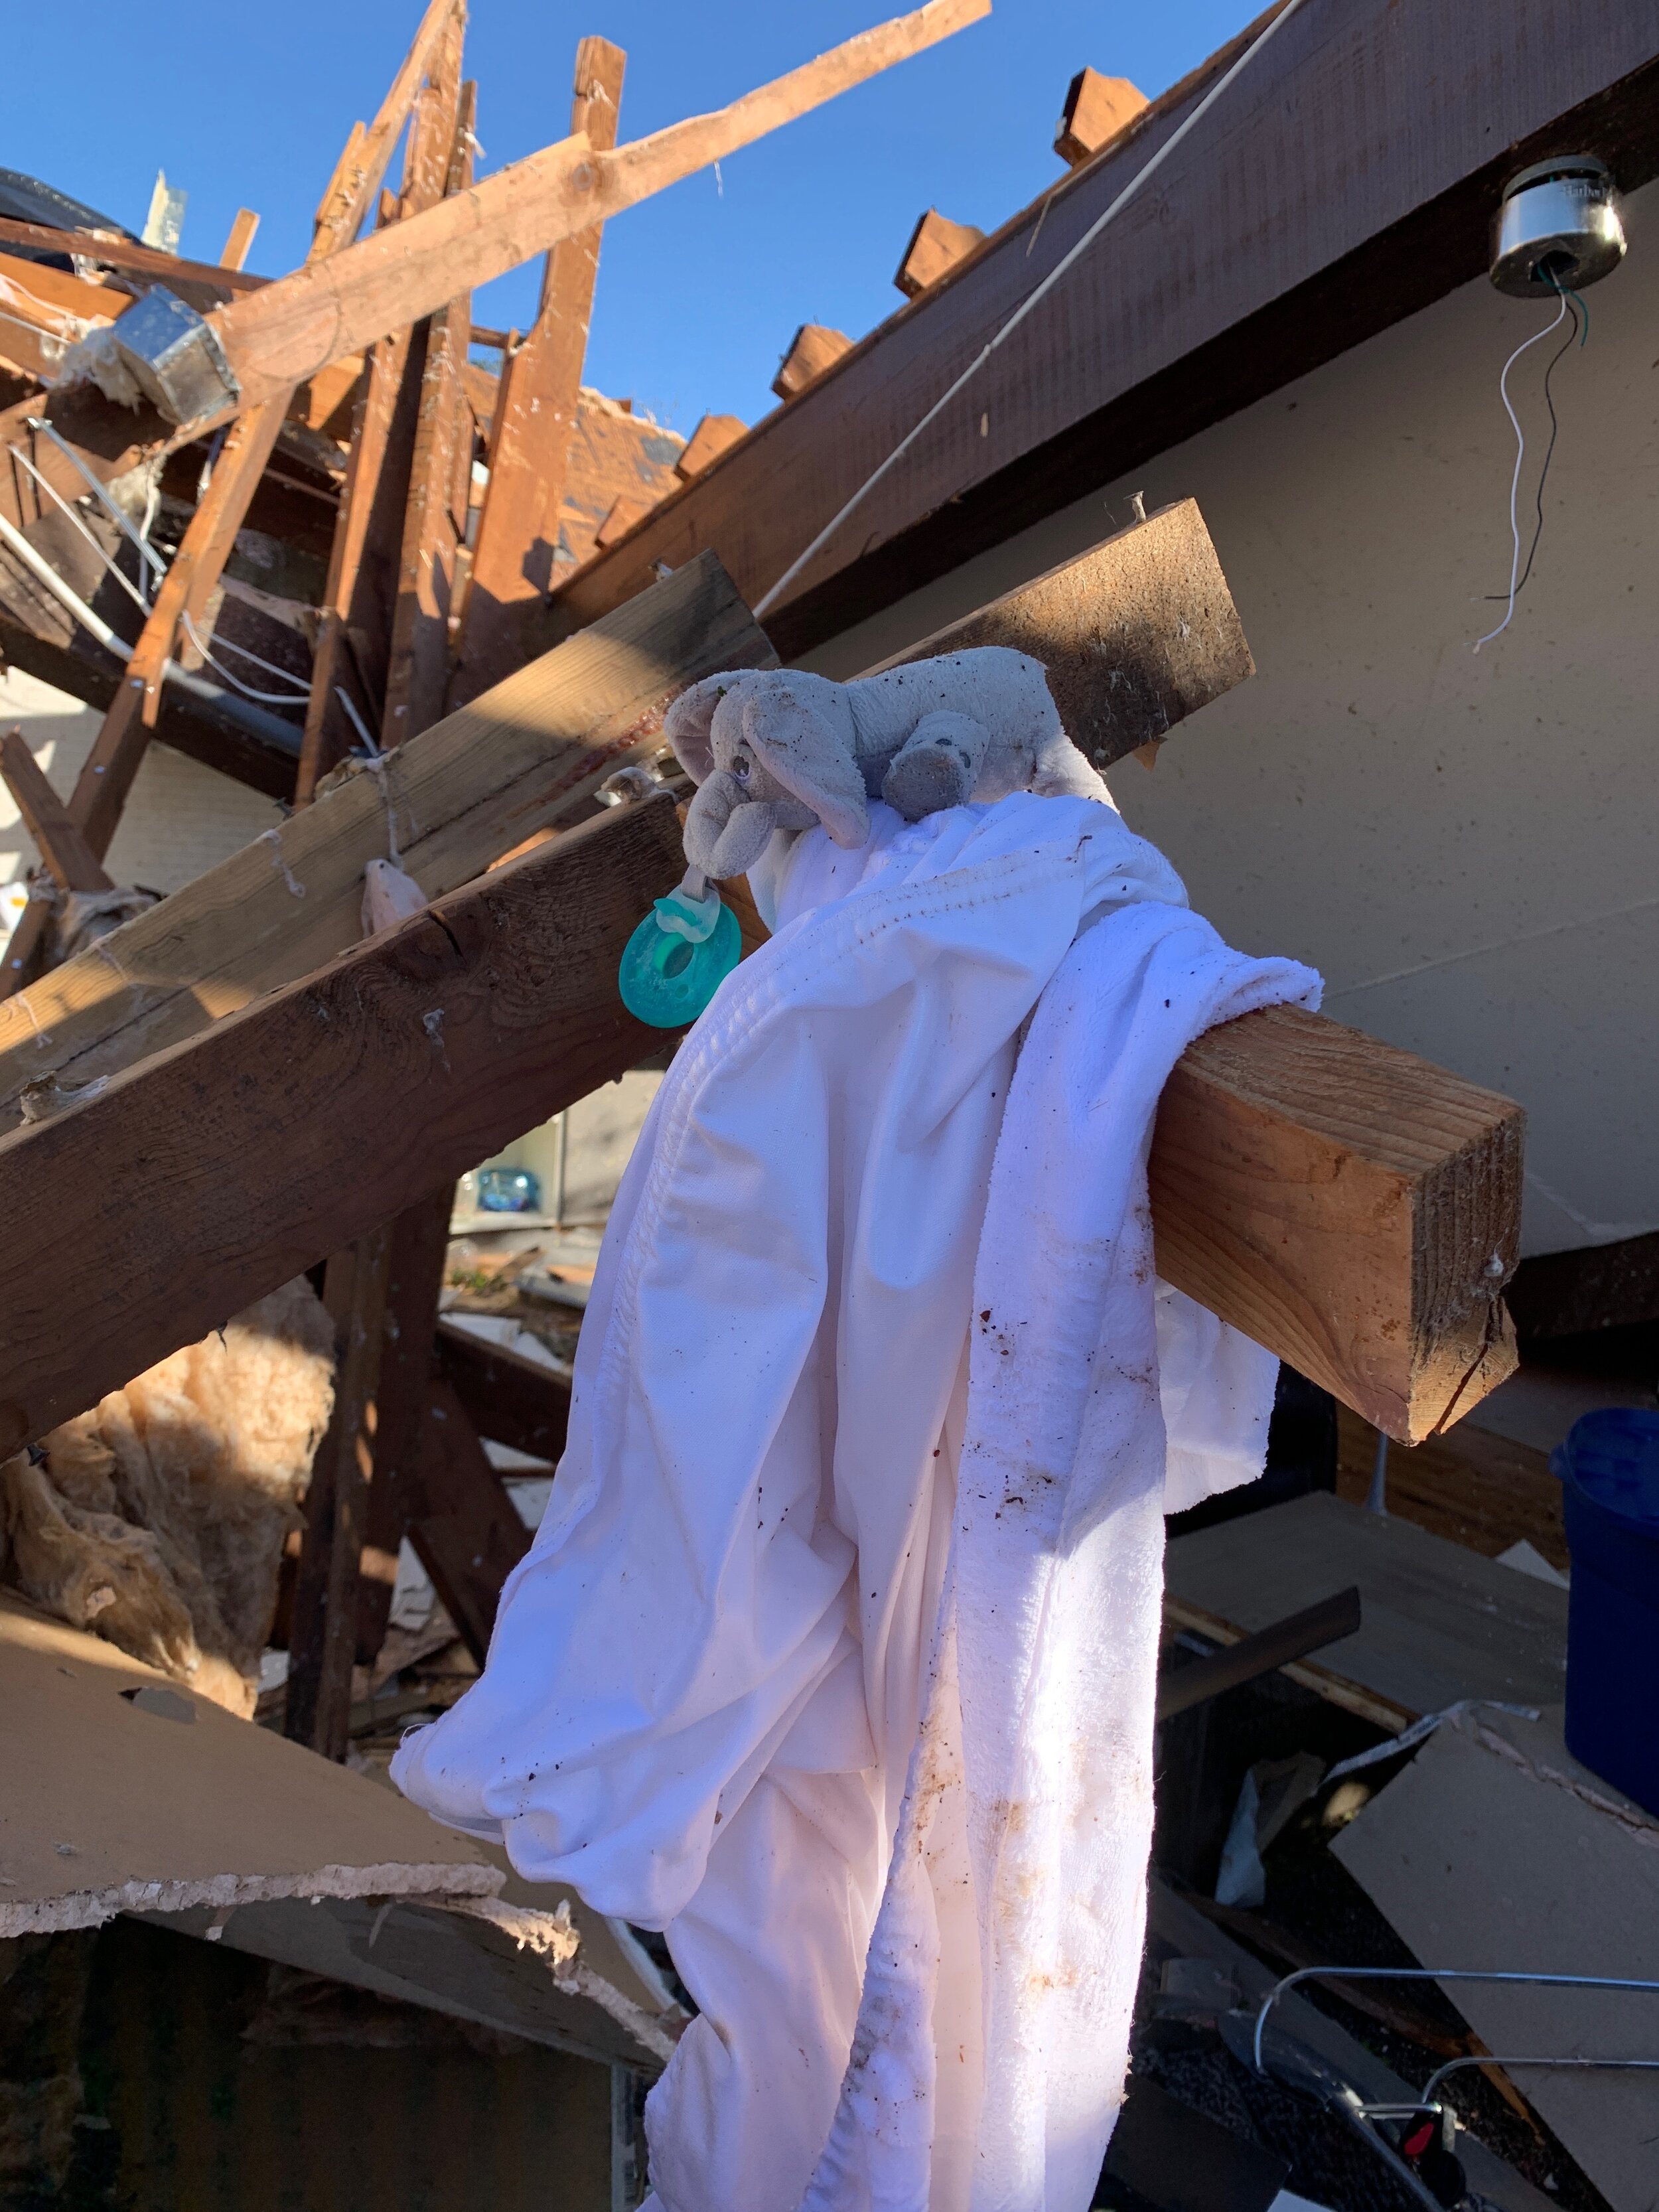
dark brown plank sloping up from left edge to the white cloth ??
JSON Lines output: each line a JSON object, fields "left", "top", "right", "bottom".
{"left": 0, "top": 798, "right": 685, "bottom": 1451}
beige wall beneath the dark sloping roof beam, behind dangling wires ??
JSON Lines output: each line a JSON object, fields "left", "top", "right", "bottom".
{"left": 810, "top": 188, "right": 1659, "bottom": 1252}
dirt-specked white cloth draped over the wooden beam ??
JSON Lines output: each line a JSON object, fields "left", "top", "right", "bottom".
{"left": 392, "top": 794, "right": 1319, "bottom": 2212}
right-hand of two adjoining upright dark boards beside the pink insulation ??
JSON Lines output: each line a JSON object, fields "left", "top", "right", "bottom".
{"left": 356, "top": 1183, "right": 453, "bottom": 1666}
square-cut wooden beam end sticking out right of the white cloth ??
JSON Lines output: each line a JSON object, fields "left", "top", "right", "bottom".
{"left": 1150, "top": 1007, "right": 1524, "bottom": 1444}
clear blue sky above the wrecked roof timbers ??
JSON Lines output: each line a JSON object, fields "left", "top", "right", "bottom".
{"left": 0, "top": 0, "right": 1254, "bottom": 431}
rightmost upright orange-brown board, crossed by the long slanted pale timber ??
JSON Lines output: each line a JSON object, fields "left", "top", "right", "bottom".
{"left": 449, "top": 38, "right": 628, "bottom": 705}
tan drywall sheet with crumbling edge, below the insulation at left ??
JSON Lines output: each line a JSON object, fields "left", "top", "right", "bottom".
{"left": 0, "top": 1593, "right": 502, "bottom": 1935}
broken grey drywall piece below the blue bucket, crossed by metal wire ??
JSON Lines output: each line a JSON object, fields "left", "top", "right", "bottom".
{"left": 1332, "top": 1708, "right": 1659, "bottom": 2212}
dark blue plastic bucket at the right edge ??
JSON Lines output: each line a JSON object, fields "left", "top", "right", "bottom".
{"left": 1551, "top": 1407, "right": 1659, "bottom": 1814}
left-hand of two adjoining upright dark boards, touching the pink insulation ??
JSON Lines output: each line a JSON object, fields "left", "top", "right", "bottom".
{"left": 283, "top": 1228, "right": 390, "bottom": 1761}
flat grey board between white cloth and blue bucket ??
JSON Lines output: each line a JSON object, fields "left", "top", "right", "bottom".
{"left": 1166, "top": 1493, "right": 1566, "bottom": 1716}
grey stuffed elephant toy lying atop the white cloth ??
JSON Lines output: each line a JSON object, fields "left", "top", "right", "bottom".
{"left": 664, "top": 646, "right": 1106, "bottom": 878}
